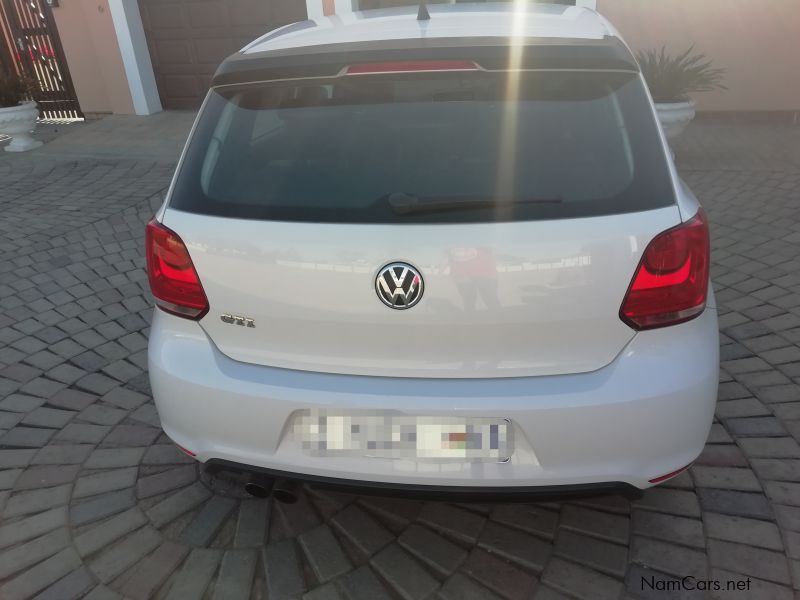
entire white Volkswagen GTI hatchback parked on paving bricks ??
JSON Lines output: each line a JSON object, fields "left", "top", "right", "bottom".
{"left": 147, "top": 4, "right": 719, "bottom": 499}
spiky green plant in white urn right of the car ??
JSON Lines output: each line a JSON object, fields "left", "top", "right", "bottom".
{"left": 636, "top": 46, "right": 728, "bottom": 139}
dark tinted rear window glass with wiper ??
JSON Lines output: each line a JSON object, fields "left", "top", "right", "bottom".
{"left": 171, "top": 71, "right": 675, "bottom": 223}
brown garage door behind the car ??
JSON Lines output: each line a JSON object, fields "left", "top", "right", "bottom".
{"left": 139, "top": 0, "right": 306, "bottom": 108}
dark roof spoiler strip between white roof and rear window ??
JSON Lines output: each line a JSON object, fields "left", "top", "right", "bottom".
{"left": 212, "top": 37, "right": 639, "bottom": 86}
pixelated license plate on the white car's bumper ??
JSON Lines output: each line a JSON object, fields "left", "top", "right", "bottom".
{"left": 293, "top": 410, "right": 513, "bottom": 462}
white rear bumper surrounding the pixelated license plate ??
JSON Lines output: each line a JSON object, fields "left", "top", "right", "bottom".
{"left": 149, "top": 309, "right": 719, "bottom": 495}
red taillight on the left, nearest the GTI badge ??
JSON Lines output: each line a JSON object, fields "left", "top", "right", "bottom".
{"left": 145, "top": 220, "right": 208, "bottom": 320}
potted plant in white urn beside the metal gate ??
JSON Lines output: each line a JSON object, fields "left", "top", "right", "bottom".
{"left": 0, "top": 71, "right": 42, "bottom": 152}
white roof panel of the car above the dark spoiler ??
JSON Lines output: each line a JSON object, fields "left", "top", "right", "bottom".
{"left": 241, "top": 2, "right": 618, "bottom": 54}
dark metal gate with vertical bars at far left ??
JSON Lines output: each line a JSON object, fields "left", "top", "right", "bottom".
{"left": 0, "top": 0, "right": 83, "bottom": 120}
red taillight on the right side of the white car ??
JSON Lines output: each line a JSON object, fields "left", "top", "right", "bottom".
{"left": 619, "top": 210, "right": 711, "bottom": 329}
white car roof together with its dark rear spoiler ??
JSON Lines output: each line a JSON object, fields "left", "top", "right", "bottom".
{"left": 212, "top": 2, "right": 639, "bottom": 87}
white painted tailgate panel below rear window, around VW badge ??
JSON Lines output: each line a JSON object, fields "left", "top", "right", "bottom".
{"left": 164, "top": 206, "right": 680, "bottom": 377}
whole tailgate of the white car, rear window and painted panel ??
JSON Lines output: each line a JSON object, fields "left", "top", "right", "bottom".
{"left": 164, "top": 61, "right": 680, "bottom": 377}
